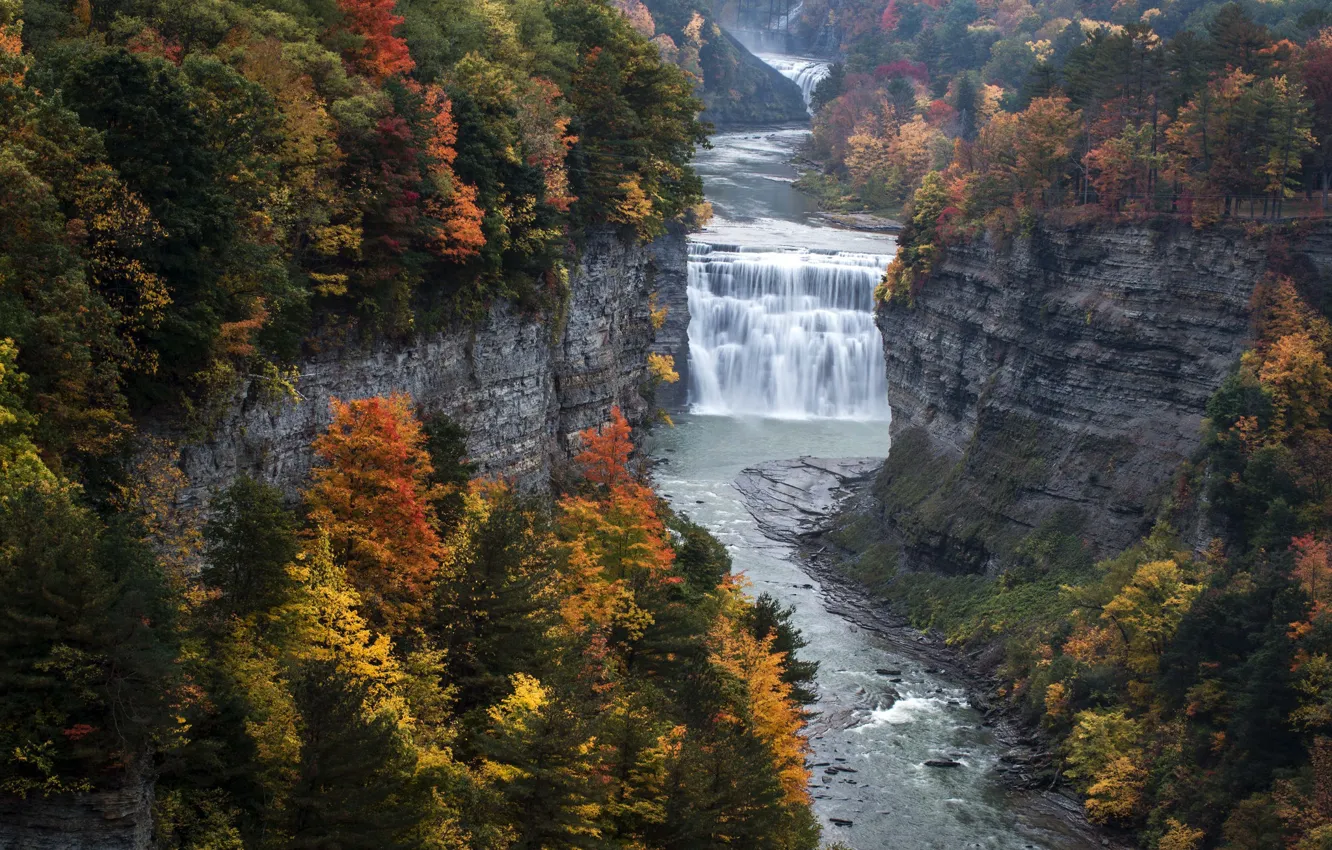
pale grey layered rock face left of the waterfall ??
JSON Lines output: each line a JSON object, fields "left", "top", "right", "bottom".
{"left": 181, "top": 230, "right": 685, "bottom": 508}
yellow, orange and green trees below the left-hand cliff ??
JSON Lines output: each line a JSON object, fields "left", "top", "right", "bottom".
{"left": 0, "top": 389, "right": 818, "bottom": 850}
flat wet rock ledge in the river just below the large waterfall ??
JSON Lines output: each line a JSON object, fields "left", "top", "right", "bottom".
{"left": 735, "top": 457, "right": 883, "bottom": 544}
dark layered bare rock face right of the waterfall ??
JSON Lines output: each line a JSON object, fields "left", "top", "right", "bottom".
{"left": 874, "top": 225, "right": 1332, "bottom": 570}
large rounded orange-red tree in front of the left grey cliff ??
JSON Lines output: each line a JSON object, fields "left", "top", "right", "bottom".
{"left": 305, "top": 393, "right": 445, "bottom": 626}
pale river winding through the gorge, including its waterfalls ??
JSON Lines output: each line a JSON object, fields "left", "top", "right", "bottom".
{"left": 650, "top": 57, "right": 1088, "bottom": 850}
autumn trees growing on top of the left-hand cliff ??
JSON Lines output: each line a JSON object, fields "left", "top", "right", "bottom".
{"left": 0, "top": 0, "right": 702, "bottom": 458}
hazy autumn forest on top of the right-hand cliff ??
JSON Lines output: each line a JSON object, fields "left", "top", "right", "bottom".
{"left": 802, "top": 0, "right": 1332, "bottom": 296}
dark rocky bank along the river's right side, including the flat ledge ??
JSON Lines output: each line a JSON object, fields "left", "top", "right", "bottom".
{"left": 735, "top": 457, "right": 1126, "bottom": 849}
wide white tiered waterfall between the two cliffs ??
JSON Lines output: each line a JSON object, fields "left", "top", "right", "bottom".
{"left": 689, "top": 242, "right": 890, "bottom": 420}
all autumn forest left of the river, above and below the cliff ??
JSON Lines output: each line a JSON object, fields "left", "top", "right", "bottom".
{"left": 0, "top": 0, "right": 819, "bottom": 850}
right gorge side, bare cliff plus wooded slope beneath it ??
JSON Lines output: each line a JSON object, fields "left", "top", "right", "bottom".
{"left": 822, "top": 218, "right": 1332, "bottom": 849}
